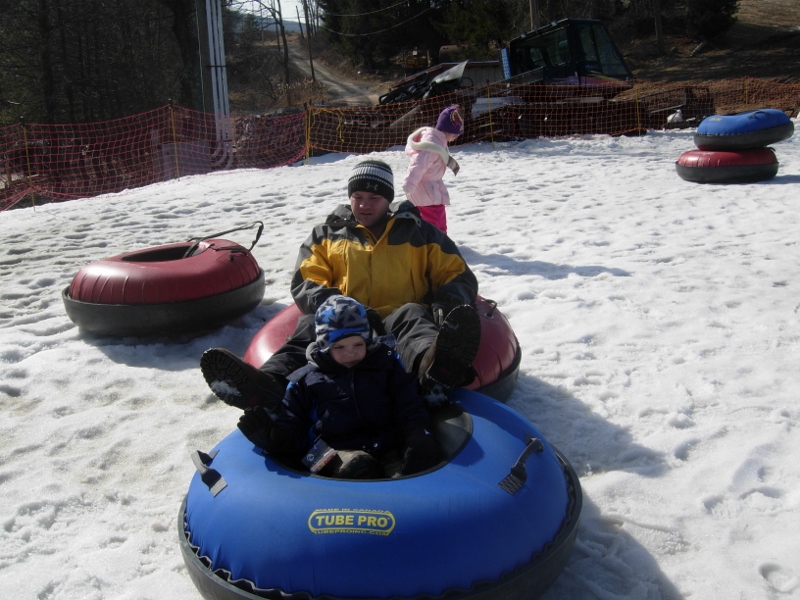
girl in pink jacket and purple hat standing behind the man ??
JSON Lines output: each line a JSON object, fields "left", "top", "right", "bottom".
{"left": 403, "top": 106, "right": 464, "bottom": 233}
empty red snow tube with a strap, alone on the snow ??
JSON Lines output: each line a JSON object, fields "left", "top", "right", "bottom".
{"left": 62, "top": 222, "right": 264, "bottom": 336}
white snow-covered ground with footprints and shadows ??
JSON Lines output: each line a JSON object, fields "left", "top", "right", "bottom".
{"left": 0, "top": 124, "right": 800, "bottom": 600}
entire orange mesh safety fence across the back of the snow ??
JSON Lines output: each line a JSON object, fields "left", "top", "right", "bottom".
{"left": 0, "top": 78, "right": 800, "bottom": 210}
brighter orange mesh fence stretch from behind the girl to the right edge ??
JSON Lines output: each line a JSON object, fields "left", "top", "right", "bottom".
{"left": 307, "top": 78, "right": 800, "bottom": 153}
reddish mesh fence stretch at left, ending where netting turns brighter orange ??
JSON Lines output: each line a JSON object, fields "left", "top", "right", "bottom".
{"left": 0, "top": 106, "right": 305, "bottom": 210}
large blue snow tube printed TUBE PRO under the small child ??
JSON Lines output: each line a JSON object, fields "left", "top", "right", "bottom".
{"left": 178, "top": 389, "right": 582, "bottom": 600}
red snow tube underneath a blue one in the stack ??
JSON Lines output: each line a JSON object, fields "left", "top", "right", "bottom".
{"left": 675, "top": 148, "right": 778, "bottom": 183}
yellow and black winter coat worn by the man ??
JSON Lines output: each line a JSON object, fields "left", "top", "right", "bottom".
{"left": 292, "top": 201, "right": 478, "bottom": 318}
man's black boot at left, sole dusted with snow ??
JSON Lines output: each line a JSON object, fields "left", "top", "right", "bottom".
{"left": 200, "top": 348, "right": 286, "bottom": 411}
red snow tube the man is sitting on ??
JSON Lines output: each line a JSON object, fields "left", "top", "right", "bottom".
{"left": 244, "top": 296, "right": 522, "bottom": 401}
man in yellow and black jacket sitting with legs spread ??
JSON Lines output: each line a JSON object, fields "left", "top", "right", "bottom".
{"left": 200, "top": 160, "right": 480, "bottom": 409}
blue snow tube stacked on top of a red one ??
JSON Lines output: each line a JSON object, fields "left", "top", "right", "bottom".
{"left": 694, "top": 108, "right": 794, "bottom": 151}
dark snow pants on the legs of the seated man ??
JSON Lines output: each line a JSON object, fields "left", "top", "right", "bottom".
{"left": 260, "top": 304, "right": 439, "bottom": 379}
